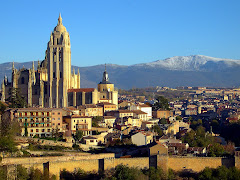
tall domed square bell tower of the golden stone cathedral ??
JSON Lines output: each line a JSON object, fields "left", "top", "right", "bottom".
{"left": 45, "top": 14, "right": 71, "bottom": 108}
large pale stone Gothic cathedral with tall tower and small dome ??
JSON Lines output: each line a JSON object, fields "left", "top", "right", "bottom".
{"left": 1, "top": 15, "right": 118, "bottom": 108}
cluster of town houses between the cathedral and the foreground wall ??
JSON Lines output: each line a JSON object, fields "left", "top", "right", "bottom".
{"left": 1, "top": 87, "right": 240, "bottom": 157}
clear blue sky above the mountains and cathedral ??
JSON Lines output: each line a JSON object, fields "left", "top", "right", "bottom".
{"left": 0, "top": 0, "right": 240, "bottom": 66}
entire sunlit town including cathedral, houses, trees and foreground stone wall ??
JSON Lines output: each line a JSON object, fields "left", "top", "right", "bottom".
{"left": 0, "top": 15, "right": 240, "bottom": 179}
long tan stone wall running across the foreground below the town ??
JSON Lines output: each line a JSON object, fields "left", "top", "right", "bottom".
{"left": 1, "top": 153, "right": 237, "bottom": 178}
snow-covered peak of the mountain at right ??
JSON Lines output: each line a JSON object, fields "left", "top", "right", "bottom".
{"left": 135, "top": 55, "right": 240, "bottom": 71}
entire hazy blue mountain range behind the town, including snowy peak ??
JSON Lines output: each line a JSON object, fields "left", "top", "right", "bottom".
{"left": 0, "top": 55, "right": 240, "bottom": 89}
